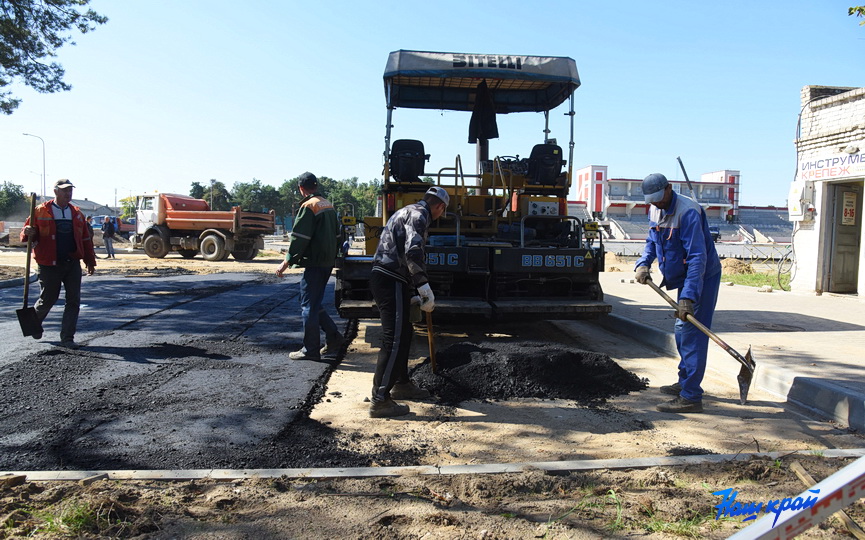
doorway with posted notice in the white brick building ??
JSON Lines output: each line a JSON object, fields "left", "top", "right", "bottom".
{"left": 829, "top": 182, "right": 863, "bottom": 293}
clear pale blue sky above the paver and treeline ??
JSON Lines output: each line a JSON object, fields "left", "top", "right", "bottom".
{"left": 0, "top": 0, "right": 865, "bottom": 206}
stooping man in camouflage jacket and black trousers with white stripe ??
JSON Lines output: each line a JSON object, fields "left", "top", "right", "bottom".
{"left": 369, "top": 186, "right": 450, "bottom": 418}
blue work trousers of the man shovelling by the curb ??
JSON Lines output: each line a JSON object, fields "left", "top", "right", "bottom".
{"left": 675, "top": 272, "right": 721, "bottom": 401}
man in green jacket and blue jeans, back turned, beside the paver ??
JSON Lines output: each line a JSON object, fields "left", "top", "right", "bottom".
{"left": 276, "top": 172, "right": 345, "bottom": 360}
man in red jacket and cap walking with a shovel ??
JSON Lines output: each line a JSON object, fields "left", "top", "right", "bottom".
{"left": 21, "top": 180, "right": 96, "bottom": 349}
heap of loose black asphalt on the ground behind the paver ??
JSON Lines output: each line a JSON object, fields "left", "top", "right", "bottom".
{"left": 411, "top": 340, "right": 648, "bottom": 405}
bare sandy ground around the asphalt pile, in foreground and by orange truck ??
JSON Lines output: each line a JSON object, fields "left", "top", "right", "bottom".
{"left": 0, "top": 250, "right": 865, "bottom": 540}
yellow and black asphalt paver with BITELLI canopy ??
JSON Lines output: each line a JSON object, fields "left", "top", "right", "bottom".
{"left": 335, "top": 50, "right": 611, "bottom": 320}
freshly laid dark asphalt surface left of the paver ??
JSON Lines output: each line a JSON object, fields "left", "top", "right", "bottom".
{"left": 0, "top": 274, "right": 347, "bottom": 470}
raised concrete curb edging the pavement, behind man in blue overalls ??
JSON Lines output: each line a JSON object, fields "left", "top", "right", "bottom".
{"left": 597, "top": 314, "right": 865, "bottom": 432}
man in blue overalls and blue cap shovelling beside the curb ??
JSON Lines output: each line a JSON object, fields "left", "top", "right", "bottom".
{"left": 635, "top": 173, "right": 721, "bottom": 413}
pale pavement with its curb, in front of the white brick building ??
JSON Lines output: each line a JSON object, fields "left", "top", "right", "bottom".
{"left": 598, "top": 272, "right": 865, "bottom": 431}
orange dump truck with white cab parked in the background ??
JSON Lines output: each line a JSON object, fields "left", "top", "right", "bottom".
{"left": 132, "top": 193, "right": 276, "bottom": 261}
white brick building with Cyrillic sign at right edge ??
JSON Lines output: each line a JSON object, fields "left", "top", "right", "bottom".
{"left": 787, "top": 86, "right": 865, "bottom": 294}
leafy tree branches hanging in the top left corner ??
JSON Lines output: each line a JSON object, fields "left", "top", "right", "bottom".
{"left": 0, "top": 0, "right": 108, "bottom": 114}
